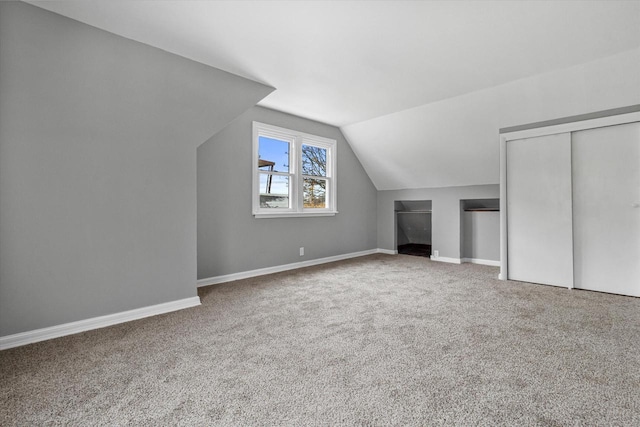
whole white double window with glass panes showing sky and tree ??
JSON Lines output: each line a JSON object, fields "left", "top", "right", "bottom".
{"left": 252, "top": 122, "right": 337, "bottom": 218}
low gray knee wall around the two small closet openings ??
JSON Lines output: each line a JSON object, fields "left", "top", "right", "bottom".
{"left": 377, "top": 184, "right": 500, "bottom": 259}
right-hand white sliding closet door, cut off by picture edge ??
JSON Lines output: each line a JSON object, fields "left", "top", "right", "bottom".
{"left": 572, "top": 122, "right": 640, "bottom": 296}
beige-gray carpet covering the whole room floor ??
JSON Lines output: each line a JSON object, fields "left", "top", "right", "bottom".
{"left": 0, "top": 255, "right": 640, "bottom": 426}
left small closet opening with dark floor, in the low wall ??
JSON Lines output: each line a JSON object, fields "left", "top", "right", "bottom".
{"left": 394, "top": 200, "right": 432, "bottom": 258}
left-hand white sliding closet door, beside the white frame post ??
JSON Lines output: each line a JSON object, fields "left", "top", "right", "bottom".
{"left": 506, "top": 133, "right": 573, "bottom": 287}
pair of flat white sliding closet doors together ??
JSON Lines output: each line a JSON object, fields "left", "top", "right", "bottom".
{"left": 503, "top": 116, "right": 640, "bottom": 296}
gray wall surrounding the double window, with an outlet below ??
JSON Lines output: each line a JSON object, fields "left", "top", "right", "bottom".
{"left": 198, "top": 107, "right": 380, "bottom": 279}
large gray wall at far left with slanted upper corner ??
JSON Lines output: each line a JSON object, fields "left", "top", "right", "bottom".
{"left": 0, "top": 2, "right": 272, "bottom": 335}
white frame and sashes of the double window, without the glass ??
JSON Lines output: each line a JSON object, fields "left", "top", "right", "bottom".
{"left": 251, "top": 122, "right": 338, "bottom": 218}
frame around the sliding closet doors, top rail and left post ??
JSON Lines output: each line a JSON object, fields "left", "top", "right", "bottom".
{"left": 498, "top": 110, "right": 640, "bottom": 288}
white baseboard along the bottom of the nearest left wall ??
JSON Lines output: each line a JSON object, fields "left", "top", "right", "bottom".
{"left": 0, "top": 297, "right": 200, "bottom": 350}
